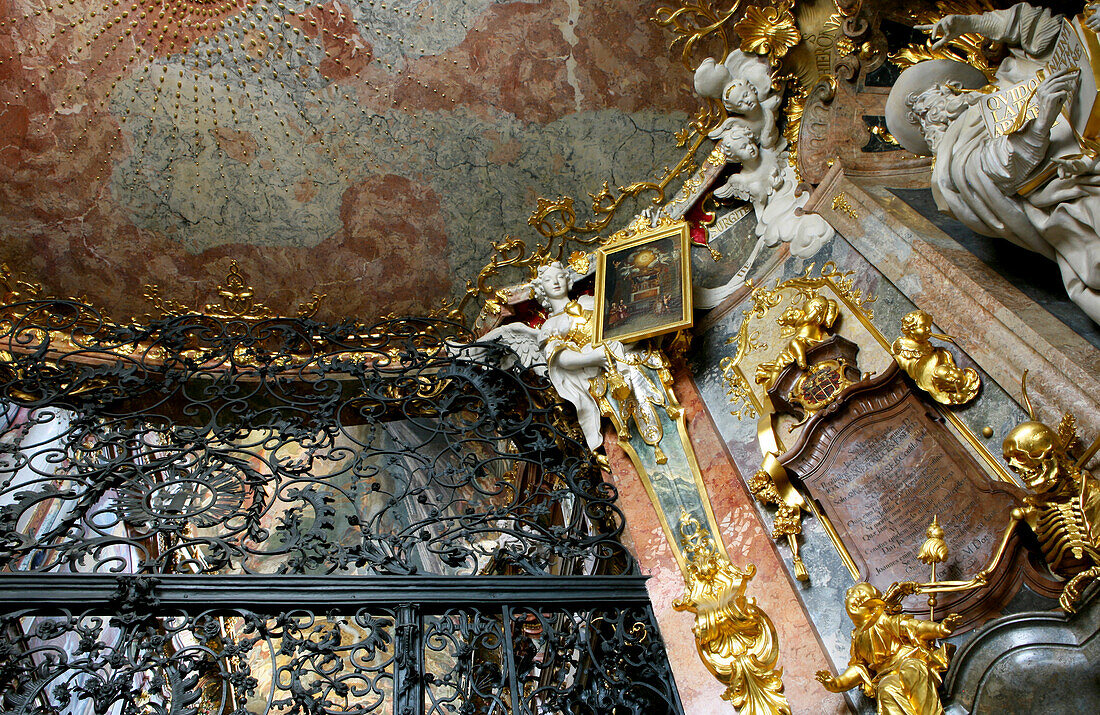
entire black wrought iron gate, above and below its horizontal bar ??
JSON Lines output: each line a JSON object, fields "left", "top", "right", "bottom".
{"left": 0, "top": 299, "right": 681, "bottom": 715}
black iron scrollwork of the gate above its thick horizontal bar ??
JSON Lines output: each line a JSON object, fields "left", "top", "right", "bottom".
{"left": 0, "top": 301, "right": 634, "bottom": 574}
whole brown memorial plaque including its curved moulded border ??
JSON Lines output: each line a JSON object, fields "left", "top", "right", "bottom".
{"left": 780, "top": 365, "right": 1022, "bottom": 622}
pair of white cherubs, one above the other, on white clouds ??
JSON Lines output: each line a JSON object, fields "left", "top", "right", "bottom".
{"left": 695, "top": 50, "right": 834, "bottom": 261}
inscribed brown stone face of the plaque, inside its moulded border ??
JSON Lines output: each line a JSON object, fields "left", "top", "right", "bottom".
{"left": 805, "top": 400, "right": 1012, "bottom": 587}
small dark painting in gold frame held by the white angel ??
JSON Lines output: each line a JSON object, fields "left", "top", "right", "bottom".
{"left": 593, "top": 221, "right": 692, "bottom": 345}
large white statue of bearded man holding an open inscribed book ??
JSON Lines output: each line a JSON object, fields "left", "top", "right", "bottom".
{"left": 887, "top": 3, "right": 1100, "bottom": 322}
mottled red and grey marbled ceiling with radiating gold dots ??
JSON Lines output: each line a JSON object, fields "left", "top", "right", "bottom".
{"left": 0, "top": 0, "right": 695, "bottom": 319}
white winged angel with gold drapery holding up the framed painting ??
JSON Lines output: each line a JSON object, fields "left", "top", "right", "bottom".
{"left": 482, "top": 262, "right": 667, "bottom": 450}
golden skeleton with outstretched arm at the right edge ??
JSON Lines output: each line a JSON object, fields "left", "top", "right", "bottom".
{"left": 914, "top": 373, "right": 1100, "bottom": 613}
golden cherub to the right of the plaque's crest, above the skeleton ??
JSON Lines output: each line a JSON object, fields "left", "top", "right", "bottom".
{"left": 890, "top": 310, "right": 981, "bottom": 405}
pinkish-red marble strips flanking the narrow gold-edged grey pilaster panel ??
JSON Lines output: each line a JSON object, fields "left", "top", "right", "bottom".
{"left": 605, "top": 370, "right": 849, "bottom": 715}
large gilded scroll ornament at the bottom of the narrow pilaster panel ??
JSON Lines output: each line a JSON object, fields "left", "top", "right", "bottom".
{"left": 672, "top": 512, "right": 791, "bottom": 715}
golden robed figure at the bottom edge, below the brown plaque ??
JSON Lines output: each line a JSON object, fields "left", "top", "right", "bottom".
{"left": 817, "top": 582, "right": 959, "bottom": 715}
